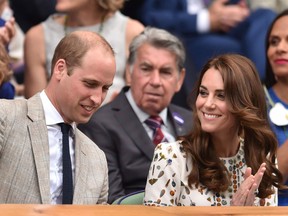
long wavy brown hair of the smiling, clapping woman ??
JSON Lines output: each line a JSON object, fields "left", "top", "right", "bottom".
{"left": 180, "top": 54, "right": 282, "bottom": 198}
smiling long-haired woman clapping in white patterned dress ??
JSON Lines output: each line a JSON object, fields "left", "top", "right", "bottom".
{"left": 144, "top": 54, "right": 284, "bottom": 206}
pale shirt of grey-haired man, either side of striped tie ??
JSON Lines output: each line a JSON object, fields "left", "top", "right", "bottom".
{"left": 125, "top": 89, "right": 176, "bottom": 142}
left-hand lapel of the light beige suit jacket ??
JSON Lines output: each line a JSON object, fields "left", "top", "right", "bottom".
{"left": 27, "top": 94, "right": 50, "bottom": 204}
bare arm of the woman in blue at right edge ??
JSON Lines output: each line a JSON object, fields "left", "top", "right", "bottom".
{"left": 277, "top": 139, "right": 288, "bottom": 183}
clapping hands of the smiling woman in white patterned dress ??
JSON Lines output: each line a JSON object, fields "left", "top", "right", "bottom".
{"left": 231, "top": 163, "right": 266, "bottom": 206}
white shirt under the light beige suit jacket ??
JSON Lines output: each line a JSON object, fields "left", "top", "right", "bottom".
{"left": 40, "top": 90, "right": 76, "bottom": 204}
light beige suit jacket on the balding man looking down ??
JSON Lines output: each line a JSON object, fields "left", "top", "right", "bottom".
{"left": 0, "top": 94, "right": 108, "bottom": 204}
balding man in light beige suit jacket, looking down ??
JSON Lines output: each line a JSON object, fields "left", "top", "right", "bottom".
{"left": 0, "top": 31, "right": 116, "bottom": 204}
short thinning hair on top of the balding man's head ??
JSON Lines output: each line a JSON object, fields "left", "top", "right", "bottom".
{"left": 51, "top": 31, "right": 114, "bottom": 75}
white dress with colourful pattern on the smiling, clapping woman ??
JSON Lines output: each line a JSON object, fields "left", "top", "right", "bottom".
{"left": 144, "top": 141, "right": 278, "bottom": 206}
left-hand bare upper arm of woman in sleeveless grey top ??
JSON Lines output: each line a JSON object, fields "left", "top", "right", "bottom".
{"left": 24, "top": 25, "right": 47, "bottom": 98}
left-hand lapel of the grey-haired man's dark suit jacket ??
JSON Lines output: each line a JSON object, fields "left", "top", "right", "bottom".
{"left": 112, "top": 90, "right": 155, "bottom": 160}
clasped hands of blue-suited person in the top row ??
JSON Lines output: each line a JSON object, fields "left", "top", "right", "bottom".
{"left": 209, "top": 0, "right": 250, "bottom": 32}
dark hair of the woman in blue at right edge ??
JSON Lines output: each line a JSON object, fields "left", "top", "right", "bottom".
{"left": 264, "top": 9, "right": 288, "bottom": 88}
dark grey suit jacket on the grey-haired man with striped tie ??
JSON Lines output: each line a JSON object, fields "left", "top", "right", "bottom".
{"left": 79, "top": 88, "right": 192, "bottom": 203}
